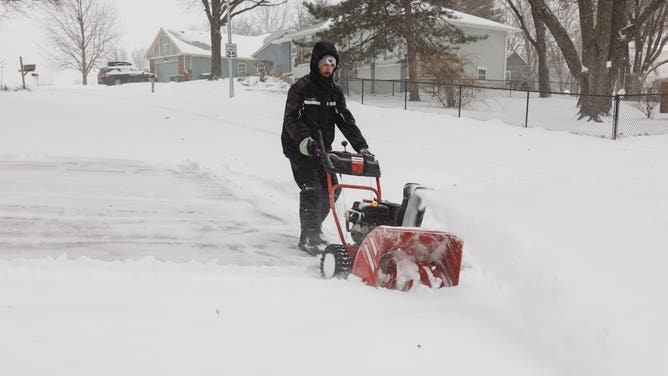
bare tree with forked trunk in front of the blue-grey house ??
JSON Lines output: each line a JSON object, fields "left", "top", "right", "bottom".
{"left": 193, "top": 0, "right": 285, "bottom": 80}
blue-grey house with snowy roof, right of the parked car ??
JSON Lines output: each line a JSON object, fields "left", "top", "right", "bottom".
{"left": 146, "top": 28, "right": 267, "bottom": 82}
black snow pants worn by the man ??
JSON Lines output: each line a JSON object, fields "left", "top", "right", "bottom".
{"left": 290, "top": 158, "right": 341, "bottom": 240}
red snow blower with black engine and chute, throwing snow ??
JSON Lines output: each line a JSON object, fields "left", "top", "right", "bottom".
{"left": 319, "top": 136, "right": 462, "bottom": 291}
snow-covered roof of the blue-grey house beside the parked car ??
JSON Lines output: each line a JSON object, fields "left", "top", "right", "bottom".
{"left": 148, "top": 28, "right": 269, "bottom": 59}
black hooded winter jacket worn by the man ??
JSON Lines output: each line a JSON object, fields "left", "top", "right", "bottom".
{"left": 281, "top": 42, "right": 368, "bottom": 159}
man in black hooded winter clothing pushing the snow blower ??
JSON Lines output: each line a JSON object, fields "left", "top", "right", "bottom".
{"left": 281, "top": 41, "right": 373, "bottom": 255}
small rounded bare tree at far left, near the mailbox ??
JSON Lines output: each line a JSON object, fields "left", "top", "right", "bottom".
{"left": 45, "top": 0, "right": 120, "bottom": 85}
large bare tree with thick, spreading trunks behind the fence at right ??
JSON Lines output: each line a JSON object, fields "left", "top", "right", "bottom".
{"left": 528, "top": 0, "right": 666, "bottom": 121}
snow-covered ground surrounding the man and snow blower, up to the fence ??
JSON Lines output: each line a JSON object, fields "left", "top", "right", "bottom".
{"left": 0, "top": 81, "right": 668, "bottom": 376}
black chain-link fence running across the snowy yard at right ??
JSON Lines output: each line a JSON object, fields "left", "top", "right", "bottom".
{"left": 339, "top": 79, "right": 668, "bottom": 139}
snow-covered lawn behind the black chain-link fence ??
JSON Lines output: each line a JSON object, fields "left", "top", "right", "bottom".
{"left": 349, "top": 81, "right": 668, "bottom": 138}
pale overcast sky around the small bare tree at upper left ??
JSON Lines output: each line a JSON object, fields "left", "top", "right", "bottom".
{"left": 0, "top": 0, "right": 207, "bottom": 86}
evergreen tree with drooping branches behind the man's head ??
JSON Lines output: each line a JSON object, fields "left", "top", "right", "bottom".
{"left": 306, "top": 0, "right": 476, "bottom": 101}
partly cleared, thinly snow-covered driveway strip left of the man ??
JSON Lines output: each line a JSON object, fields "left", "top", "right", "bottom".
{"left": 0, "top": 158, "right": 297, "bottom": 265}
